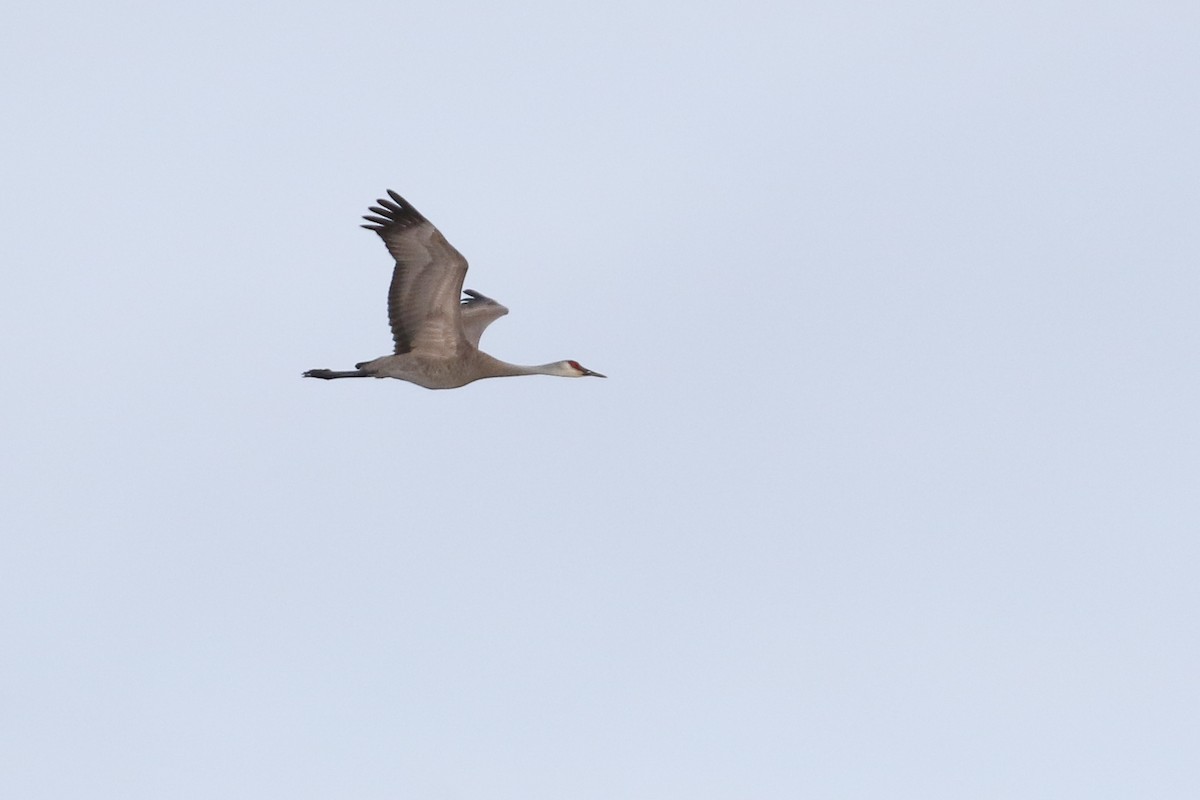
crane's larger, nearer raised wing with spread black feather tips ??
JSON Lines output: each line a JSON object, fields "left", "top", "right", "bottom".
{"left": 362, "top": 190, "right": 467, "bottom": 356}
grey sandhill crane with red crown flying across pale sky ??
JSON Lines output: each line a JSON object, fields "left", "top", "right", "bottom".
{"left": 304, "top": 190, "right": 605, "bottom": 389}
